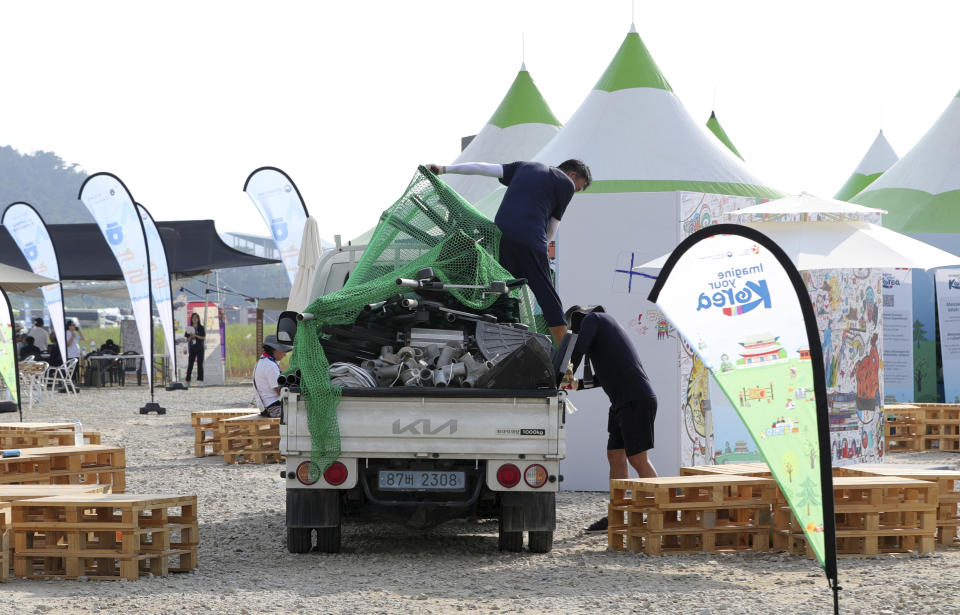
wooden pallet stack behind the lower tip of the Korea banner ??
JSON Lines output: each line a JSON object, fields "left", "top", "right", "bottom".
{"left": 774, "top": 476, "right": 939, "bottom": 557}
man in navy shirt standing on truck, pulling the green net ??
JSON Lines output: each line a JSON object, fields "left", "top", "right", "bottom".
{"left": 427, "top": 159, "right": 591, "bottom": 344}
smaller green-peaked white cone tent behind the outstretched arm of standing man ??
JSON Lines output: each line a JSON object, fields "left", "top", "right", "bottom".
{"left": 443, "top": 64, "right": 561, "bottom": 203}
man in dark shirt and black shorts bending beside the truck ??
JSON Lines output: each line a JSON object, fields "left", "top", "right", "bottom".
{"left": 566, "top": 305, "right": 657, "bottom": 531}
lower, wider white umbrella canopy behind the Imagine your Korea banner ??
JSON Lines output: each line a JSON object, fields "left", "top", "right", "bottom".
{"left": 634, "top": 219, "right": 960, "bottom": 270}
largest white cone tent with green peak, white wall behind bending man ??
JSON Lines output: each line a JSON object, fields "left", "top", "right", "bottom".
{"left": 516, "top": 22, "right": 783, "bottom": 490}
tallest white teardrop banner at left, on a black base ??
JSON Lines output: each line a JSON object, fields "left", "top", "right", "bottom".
{"left": 80, "top": 173, "right": 153, "bottom": 386}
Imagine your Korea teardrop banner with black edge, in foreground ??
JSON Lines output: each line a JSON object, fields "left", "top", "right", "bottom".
{"left": 649, "top": 224, "right": 839, "bottom": 611}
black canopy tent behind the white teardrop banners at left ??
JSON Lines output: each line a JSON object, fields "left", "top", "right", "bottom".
{"left": 0, "top": 220, "right": 280, "bottom": 280}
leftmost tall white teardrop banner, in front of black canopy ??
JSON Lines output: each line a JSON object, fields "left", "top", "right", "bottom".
{"left": 0, "top": 203, "right": 67, "bottom": 366}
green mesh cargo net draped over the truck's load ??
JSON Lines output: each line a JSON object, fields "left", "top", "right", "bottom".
{"left": 290, "top": 167, "right": 546, "bottom": 479}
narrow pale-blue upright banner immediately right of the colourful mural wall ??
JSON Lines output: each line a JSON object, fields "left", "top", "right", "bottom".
{"left": 882, "top": 269, "right": 914, "bottom": 403}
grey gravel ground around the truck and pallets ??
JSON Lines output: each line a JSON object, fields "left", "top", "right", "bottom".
{"left": 0, "top": 387, "right": 960, "bottom": 615}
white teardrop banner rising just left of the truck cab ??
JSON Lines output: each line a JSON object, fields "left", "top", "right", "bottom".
{"left": 243, "top": 167, "right": 307, "bottom": 286}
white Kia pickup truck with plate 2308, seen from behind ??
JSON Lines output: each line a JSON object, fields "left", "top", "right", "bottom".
{"left": 280, "top": 243, "right": 575, "bottom": 553}
